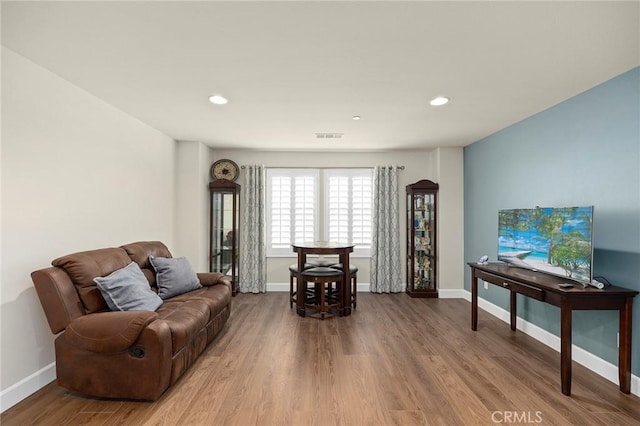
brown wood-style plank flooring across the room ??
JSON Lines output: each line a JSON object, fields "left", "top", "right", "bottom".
{"left": 0, "top": 293, "right": 640, "bottom": 426}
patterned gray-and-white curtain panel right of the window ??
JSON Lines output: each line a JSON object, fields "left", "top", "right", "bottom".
{"left": 370, "top": 166, "right": 403, "bottom": 293}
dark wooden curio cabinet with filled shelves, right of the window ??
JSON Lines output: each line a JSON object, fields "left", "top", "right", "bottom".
{"left": 407, "top": 180, "right": 438, "bottom": 297}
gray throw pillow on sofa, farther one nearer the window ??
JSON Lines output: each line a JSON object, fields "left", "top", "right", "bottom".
{"left": 149, "top": 256, "right": 202, "bottom": 299}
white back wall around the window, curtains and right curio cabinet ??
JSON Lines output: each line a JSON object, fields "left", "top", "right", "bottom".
{"left": 198, "top": 148, "right": 464, "bottom": 290}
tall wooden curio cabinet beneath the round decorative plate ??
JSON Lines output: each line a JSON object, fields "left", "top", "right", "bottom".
{"left": 209, "top": 179, "right": 240, "bottom": 296}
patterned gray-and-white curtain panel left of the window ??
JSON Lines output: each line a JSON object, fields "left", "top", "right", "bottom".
{"left": 239, "top": 165, "right": 267, "bottom": 293}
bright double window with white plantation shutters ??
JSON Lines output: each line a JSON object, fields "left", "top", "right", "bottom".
{"left": 267, "top": 169, "right": 373, "bottom": 256}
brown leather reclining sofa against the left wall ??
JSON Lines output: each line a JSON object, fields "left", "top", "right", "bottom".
{"left": 31, "top": 241, "right": 231, "bottom": 400}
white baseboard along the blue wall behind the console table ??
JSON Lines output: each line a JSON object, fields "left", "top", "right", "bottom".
{"left": 462, "top": 290, "right": 640, "bottom": 396}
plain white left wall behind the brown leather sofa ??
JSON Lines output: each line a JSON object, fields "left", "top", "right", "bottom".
{"left": 0, "top": 47, "right": 175, "bottom": 410}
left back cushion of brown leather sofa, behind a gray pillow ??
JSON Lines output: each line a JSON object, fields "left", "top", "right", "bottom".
{"left": 51, "top": 248, "right": 131, "bottom": 314}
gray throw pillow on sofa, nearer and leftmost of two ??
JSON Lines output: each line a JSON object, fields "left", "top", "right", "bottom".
{"left": 93, "top": 262, "right": 162, "bottom": 311}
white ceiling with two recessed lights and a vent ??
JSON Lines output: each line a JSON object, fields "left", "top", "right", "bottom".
{"left": 2, "top": 1, "right": 640, "bottom": 151}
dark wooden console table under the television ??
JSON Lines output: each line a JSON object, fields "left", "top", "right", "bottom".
{"left": 468, "top": 262, "right": 638, "bottom": 395}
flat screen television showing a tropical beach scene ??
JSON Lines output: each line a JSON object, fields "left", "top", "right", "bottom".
{"left": 498, "top": 206, "right": 593, "bottom": 283}
